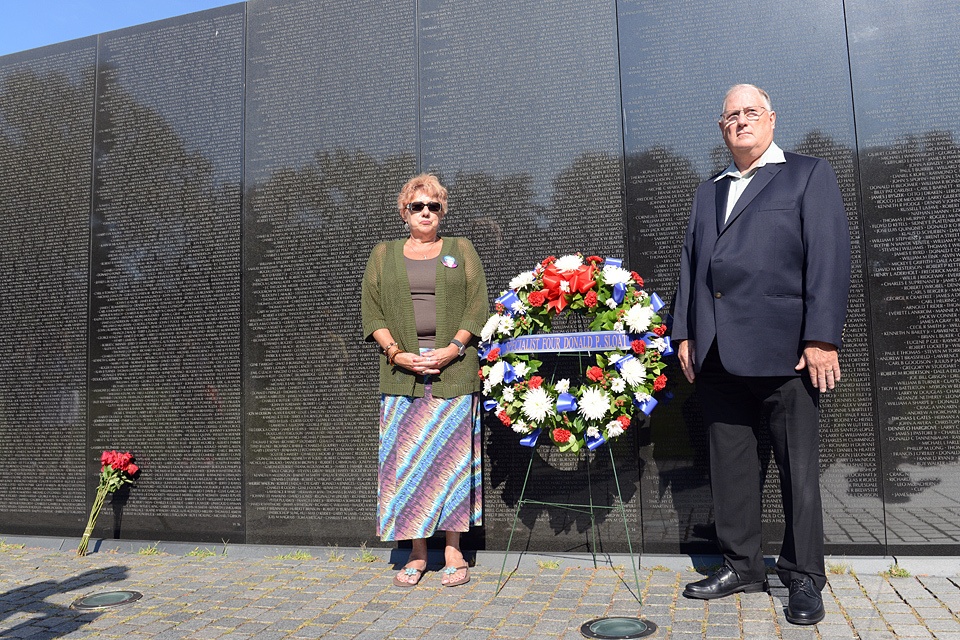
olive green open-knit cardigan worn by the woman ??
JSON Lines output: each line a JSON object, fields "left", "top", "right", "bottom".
{"left": 360, "top": 236, "right": 489, "bottom": 398}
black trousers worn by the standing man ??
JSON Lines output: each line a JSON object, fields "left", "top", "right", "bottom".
{"left": 696, "top": 342, "right": 827, "bottom": 589}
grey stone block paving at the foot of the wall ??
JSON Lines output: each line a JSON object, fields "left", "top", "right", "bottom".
{"left": 0, "top": 541, "right": 960, "bottom": 640}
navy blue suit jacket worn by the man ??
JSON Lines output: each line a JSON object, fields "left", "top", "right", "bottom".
{"left": 671, "top": 153, "right": 850, "bottom": 376}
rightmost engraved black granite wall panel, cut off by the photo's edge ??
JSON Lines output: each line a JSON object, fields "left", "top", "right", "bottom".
{"left": 847, "top": 0, "right": 960, "bottom": 555}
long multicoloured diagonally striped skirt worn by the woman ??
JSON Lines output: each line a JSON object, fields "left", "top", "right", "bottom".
{"left": 377, "top": 387, "right": 482, "bottom": 541}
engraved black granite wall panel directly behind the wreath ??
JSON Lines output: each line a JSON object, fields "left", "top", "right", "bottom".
{"left": 419, "top": 0, "right": 639, "bottom": 551}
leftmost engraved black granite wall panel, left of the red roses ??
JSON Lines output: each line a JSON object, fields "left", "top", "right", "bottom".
{"left": 0, "top": 38, "right": 97, "bottom": 535}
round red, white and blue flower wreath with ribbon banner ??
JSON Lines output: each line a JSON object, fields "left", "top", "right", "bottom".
{"left": 479, "top": 253, "right": 673, "bottom": 451}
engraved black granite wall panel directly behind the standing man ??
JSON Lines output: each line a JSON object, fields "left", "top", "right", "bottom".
{"left": 619, "top": 0, "right": 883, "bottom": 553}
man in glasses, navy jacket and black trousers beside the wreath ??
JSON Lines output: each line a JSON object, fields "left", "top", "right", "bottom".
{"left": 672, "top": 84, "right": 850, "bottom": 624}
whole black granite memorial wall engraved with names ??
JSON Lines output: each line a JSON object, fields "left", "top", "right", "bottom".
{"left": 0, "top": 0, "right": 960, "bottom": 554}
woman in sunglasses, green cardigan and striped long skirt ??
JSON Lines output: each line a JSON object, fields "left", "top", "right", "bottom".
{"left": 361, "top": 174, "right": 488, "bottom": 587}
